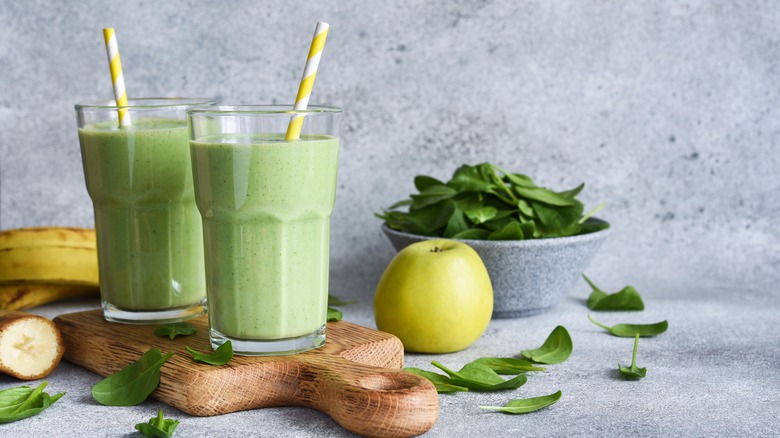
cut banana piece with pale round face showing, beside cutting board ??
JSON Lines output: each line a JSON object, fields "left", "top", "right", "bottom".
{"left": 0, "top": 310, "right": 65, "bottom": 380}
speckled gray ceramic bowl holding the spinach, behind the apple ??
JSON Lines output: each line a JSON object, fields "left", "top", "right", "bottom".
{"left": 382, "top": 219, "right": 611, "bottom": 318}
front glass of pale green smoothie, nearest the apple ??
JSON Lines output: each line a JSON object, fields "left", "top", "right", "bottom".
{"left": 188, "top": 105, "right": 341, "bottom": 355}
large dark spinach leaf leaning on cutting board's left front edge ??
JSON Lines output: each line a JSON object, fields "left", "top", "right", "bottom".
{"left": 92, "top": 348, "right": 173, "bottom": 406}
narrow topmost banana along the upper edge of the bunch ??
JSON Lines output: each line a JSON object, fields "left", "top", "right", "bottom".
{"left": 0, "top": 227, "right": 96, "bottom": 250}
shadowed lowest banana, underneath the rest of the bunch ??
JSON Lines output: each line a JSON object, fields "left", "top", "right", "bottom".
{"left": 0, "top": 283, "right": 100, "bottom": 310}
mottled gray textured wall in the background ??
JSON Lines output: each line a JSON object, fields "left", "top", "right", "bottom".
{"left": 0, "top": 0, "right": 780, "bottom": 297}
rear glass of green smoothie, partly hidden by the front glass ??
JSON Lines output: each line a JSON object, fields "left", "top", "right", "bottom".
{"left": 76, "top": 98, "right": 215, "bottom": 324}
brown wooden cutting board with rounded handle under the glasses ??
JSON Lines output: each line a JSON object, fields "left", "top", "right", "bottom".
{"left": 54, "top": 310, "right": 439, "bottom": 437}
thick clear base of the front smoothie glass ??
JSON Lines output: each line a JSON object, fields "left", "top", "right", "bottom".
{"left": 209, "top": 325, "right": 325, "bottom": 356}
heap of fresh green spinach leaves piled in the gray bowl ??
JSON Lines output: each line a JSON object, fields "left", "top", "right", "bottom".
{"left": 376, "top": 163, "right": 609, "bottom": 240}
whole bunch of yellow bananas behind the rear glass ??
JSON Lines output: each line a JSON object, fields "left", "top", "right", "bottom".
{"left": 0, "top": 227, "right": 100, "bottom": 310}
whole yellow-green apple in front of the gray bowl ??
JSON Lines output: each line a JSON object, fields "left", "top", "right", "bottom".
{"left": 374, "top": 239, "right": 493, "bottom": 353}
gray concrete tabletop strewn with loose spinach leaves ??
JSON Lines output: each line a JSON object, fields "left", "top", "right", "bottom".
{"left": 0, "top": 280, "right": 780, "bottom": 437}
